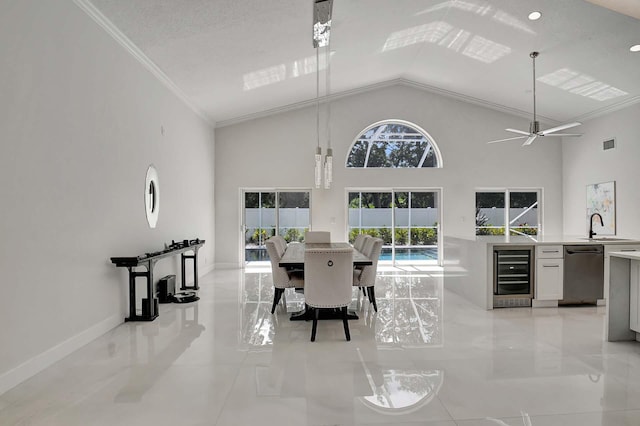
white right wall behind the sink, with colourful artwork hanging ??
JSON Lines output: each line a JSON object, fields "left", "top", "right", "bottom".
{"left": 562, "top": 104, "right": 640, "bottom": 238}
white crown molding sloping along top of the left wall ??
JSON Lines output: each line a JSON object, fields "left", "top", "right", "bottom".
{"left": 73, "top": 0, "right": 215, "bottom": 127}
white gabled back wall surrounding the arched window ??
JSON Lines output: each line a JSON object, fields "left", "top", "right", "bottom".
{"left": 215, "top": 86, "right": 562, "bottom": 265}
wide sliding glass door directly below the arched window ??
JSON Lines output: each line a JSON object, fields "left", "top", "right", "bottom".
{"left": 347, "top": 189, "right": 441, "bottom": 264}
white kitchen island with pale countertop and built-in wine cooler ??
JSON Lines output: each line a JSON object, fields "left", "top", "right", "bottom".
{"left": 443, "top": 235, "right": 640, "bottom": 309}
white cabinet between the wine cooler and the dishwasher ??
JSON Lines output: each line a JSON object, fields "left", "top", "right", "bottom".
{"left": 535, "top": 245, "right": 564, "bottom": 301}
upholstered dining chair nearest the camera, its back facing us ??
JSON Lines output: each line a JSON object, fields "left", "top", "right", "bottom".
{"left": 304, "top": 247, "right": 353, "bottom": 342}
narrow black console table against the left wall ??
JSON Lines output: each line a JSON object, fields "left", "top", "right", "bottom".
{"left": 111, "top": 238, "right": 204, "bottom": 321}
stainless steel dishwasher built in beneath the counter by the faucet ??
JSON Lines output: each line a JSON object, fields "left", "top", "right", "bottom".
{"left": 558, "top": 244, "right": 604, "bottom": 305}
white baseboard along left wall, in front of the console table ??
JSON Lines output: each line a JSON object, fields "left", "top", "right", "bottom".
{"left": 0, "top": 314, "right": 123, "bottom": 395}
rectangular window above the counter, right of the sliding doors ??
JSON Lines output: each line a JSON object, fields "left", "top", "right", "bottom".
{"left": 476, "top": 189, "right": 541, "bottom": 235}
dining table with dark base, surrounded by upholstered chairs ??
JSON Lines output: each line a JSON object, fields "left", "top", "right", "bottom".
{"left": 278, "top": 242, "right": 373, "bottom": 321}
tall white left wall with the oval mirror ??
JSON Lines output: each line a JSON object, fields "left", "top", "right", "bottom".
{"left": 0, "top": 0, "right": 214, "bottom": 393}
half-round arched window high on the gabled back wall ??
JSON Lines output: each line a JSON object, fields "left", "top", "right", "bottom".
{"left": 347, "top": 120, "right": 442, "bottom": 168}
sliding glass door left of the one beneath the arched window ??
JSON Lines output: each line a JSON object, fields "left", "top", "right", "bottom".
{"left": 242, "top": 190, "right": 310, "bottom": 262}
